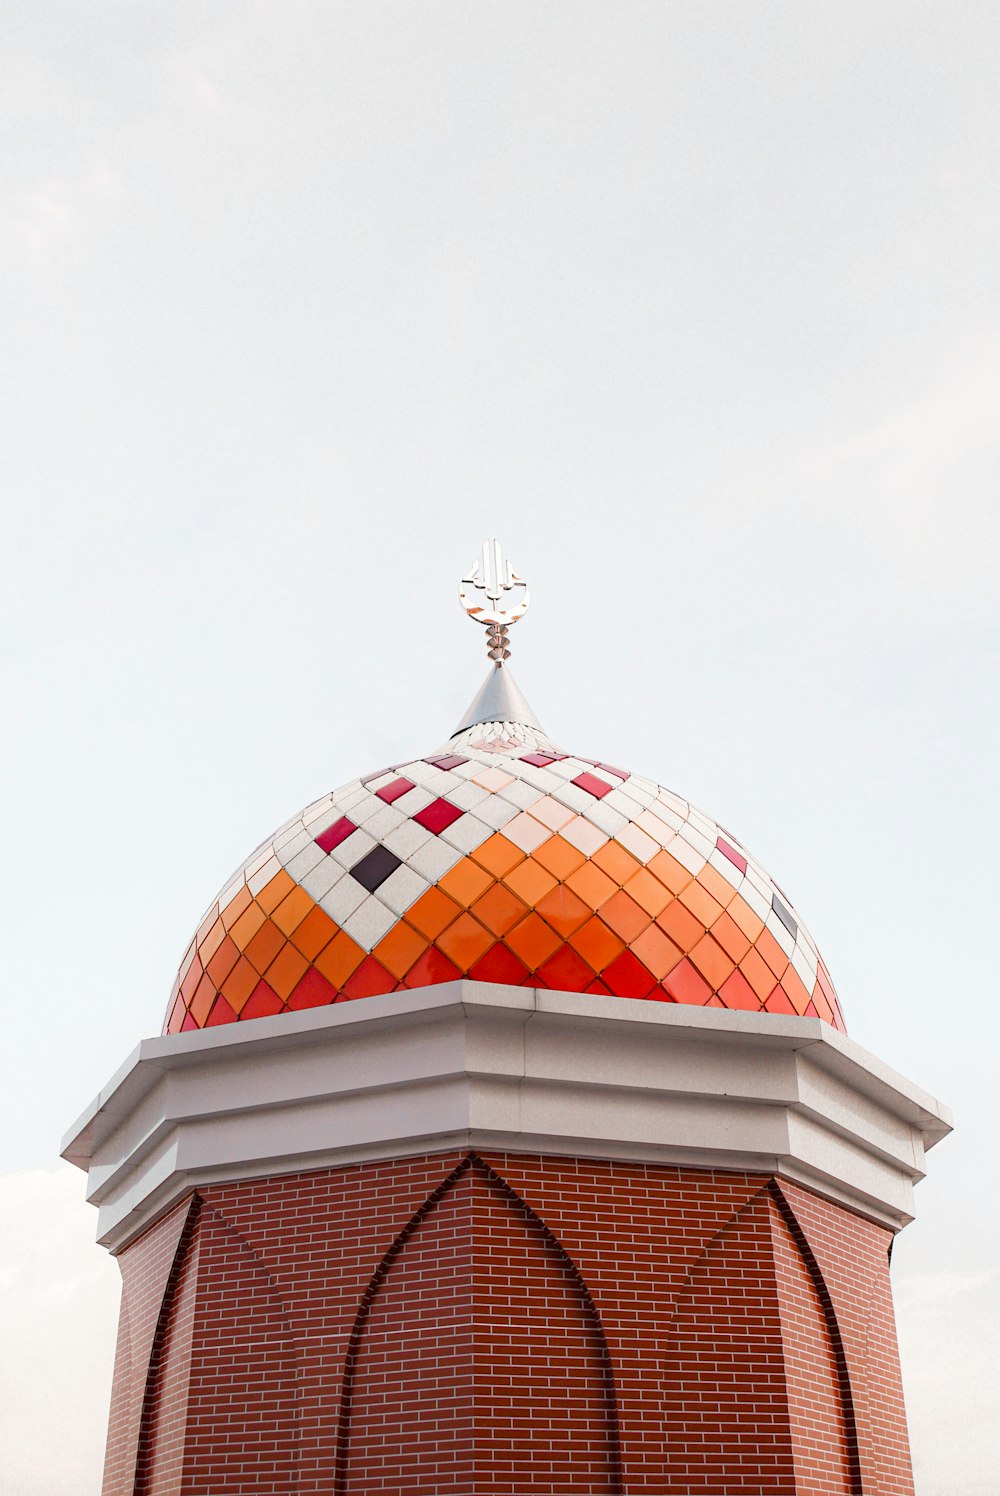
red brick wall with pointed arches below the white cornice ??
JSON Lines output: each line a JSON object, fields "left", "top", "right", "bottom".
{"left": 105, "top": 1152, "right": 912, "bottom": 1496}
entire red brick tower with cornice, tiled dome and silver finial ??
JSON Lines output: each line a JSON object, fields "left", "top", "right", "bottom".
{"left": 64, "top": 549, "right": 949, "bottom": 1496}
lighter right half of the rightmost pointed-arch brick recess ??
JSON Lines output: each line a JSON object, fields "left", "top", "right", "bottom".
{"left": 768, "top": 1180, "right": 862, "bottom": 1496}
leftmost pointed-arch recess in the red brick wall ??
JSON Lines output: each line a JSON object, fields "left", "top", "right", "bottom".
{"left": 135, "top": 1204, "right": 299, "bottom": 1496}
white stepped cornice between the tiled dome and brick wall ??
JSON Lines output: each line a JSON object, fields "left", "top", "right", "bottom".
{"left": 63, "top": 981, "right": 951, "bottom": 1252}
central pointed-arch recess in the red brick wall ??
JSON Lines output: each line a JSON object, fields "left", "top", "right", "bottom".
{"left": 337, "top": 1153, "right": 621, "bottom": 1496}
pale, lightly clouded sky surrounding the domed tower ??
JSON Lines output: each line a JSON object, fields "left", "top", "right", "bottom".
{"left": 0, "top": 0, "right": 1000, "bottom": 1496}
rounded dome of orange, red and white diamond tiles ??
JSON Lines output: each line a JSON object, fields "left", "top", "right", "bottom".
{"left": 166, "top": 685, "right": 844, "bottom": 1034}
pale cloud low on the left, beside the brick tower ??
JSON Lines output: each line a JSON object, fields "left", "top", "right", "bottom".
{"left": 0, "top": 1167, "right": 118, "bottom": 1496}
